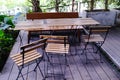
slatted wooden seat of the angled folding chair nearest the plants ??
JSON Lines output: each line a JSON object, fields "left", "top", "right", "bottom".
{"left": 11, "top": 50, "right": 42, "bottom": 66}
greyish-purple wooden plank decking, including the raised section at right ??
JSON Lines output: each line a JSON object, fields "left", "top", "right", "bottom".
{"left": 0, "top": 30, "right": 120, "bottom": 80}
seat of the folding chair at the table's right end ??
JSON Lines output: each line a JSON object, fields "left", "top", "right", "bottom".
{"left": 83, "top": 34, "right": 104, "bottom": 42}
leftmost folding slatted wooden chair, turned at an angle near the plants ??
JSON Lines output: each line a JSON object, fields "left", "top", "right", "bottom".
{"left": 11, "top": 39, "right": 47, "bottom": 80}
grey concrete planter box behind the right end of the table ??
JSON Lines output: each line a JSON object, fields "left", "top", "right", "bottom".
{"left": 82, "top": 10, "right": 116, "bottom": 26}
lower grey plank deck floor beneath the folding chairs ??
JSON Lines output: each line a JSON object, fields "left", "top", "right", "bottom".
{"left": 0, "top": 28, "right": 120, "bottom": 80}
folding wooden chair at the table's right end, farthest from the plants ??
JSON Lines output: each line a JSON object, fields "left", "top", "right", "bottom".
{"left": 82, "top": 26, "right": 111, "bottom": 63}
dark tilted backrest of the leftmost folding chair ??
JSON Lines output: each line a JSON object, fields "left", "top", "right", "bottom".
{"left": 20, "top": 38, "right": 47, "bottom": 65}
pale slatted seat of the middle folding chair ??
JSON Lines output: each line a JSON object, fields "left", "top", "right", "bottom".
{"left": 46, "top": 43, "right": 69, "bottom": 54}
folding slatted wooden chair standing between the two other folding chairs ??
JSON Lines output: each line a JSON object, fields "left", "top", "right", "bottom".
{"left": 41, "top": 35, "right": 69, "bottom": 79}
